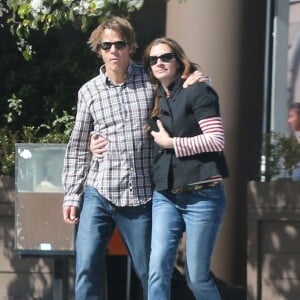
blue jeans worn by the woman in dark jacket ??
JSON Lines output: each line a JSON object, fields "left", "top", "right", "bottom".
{"left": 148, "top": 183, "right": 225, "bottom": 300}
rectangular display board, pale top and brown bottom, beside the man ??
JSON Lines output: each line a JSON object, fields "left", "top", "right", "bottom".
{"left": 15, "top": 143, "right": 75, "bottom": 256}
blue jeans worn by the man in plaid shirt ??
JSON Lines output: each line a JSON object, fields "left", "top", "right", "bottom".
{"left": 75, "top": 187, "right": 151, "bottom": 300}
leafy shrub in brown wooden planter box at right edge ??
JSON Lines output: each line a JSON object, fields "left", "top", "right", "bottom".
{"left": 247, "top": 132, "right": 300, "bottom": 299}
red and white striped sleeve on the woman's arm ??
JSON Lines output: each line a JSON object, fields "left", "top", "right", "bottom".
{"left": 173, "top": 117, "right": 225, "bottom": 157}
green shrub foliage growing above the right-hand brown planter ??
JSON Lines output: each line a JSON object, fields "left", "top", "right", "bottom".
{"left": 260, "top": 131, "right": 300, "bottom": 181}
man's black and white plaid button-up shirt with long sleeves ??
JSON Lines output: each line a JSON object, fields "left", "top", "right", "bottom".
{"left": 63, "top": 64, "right": 154, "bottom": 206}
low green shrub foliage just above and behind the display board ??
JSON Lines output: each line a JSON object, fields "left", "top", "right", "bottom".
{"left": 0, "top": 95, "right": 75, "bottom": 176}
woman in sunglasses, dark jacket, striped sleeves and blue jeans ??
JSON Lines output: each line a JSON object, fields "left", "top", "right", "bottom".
{"left": 144, "top": 38, "right": 228, "bottom": 300}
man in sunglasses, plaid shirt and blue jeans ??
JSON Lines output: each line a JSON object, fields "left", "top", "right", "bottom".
{"left": 63, "top": 17, "right": 205, "bottom": 300}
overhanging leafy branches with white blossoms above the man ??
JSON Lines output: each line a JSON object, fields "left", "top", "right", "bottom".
{"left": 0, "top": 0, "right": 144, "bottom": 60}
